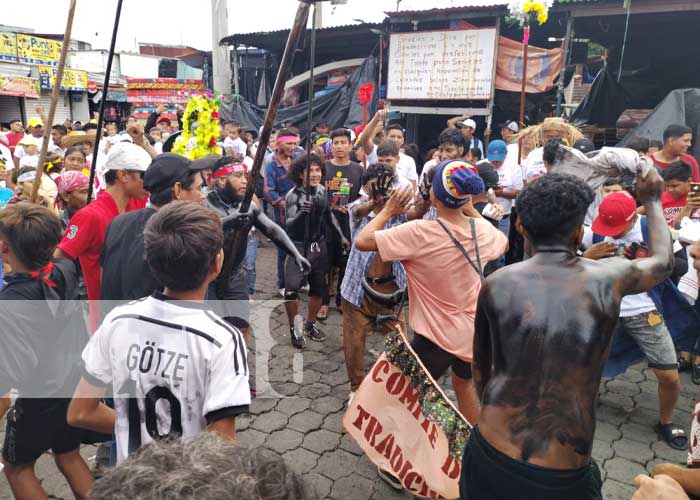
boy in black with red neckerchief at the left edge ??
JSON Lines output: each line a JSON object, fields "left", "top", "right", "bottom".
{"left": 0, "top": 203, "right": 93, "bottom": 499}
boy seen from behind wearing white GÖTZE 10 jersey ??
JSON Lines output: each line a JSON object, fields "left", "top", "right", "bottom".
{"left": 68, "top": 202, "right": 250, "bottom": 462}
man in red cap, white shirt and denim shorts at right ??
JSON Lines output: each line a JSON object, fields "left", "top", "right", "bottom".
{"left": 582, "top": 191, "right": 688, "bottom": 450}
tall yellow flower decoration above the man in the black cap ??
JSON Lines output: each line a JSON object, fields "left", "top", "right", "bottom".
{"left": 173, "top": 92, "right": 221, "bottom": 160}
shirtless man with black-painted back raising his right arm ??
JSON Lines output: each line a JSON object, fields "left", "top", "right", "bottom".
{"left": 460, "top": 170, "right": 673, "bottom": 500}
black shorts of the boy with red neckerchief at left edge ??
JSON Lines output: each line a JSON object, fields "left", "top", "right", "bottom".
{"left": 2, "top": 398, "right": 83, "bottom": 465}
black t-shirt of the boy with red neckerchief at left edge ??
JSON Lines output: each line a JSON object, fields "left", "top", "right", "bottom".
{"left": 0, "top": 259, "right": 88, "bottom": 398}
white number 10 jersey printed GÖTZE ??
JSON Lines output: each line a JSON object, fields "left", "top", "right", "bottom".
{"left": 82, "top": 296, "right": 250, "bottom": 463}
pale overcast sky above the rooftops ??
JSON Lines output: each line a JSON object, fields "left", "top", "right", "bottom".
{"left": 0, "top": 0, "right": 464, "bottom": 51}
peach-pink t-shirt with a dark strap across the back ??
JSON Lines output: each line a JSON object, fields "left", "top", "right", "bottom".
{"left": 375, "top": 219, "right": 508, "bottom": 361}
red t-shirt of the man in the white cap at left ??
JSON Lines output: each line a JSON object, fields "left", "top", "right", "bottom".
{"left": 58, "top": 191, "right": 119, "bottom": 331}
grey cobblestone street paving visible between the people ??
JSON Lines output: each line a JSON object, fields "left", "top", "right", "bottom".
{"left": 0, "top": 244, "right": 697, "bottom": 500}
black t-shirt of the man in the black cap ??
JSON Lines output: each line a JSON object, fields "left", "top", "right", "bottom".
{"left": 100, "top": 208, "right": 160, "bottom": 304}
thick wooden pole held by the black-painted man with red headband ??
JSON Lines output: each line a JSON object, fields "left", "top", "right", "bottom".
{"left": 219, "top": 0, "right": 311, "bottom": 283}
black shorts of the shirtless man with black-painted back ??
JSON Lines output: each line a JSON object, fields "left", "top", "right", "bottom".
{"left": 459, "top": 427, "right": 603, "bottom": 500}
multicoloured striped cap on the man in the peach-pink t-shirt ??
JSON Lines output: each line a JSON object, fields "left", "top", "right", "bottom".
{"left": 433, "top": 160, "right": 484, "bottom": 208}
